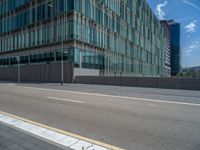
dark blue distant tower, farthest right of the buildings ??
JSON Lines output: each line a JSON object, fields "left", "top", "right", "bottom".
{"left": 167, "top": 20, "right": 181, "bottom": 76}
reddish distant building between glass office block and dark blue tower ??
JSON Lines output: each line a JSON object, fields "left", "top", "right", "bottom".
{"left": 160, "top": 20, "right": 171, "bottom": 76}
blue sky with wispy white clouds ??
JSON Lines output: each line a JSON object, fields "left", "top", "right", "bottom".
{"left": 147, "top": 0, "right": 200, "bottom": 67}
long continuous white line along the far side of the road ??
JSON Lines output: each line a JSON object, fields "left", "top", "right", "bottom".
{"left": 10, "top": 86, "right": 200, "bottom": 106}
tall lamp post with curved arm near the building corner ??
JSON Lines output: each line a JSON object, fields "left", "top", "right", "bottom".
{"left": 48, "top": 3, "right": 65, "bottom": 86}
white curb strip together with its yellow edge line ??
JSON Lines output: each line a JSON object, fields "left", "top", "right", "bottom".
{"left": 0, "top": 111, "right": 124, "bottom": 150}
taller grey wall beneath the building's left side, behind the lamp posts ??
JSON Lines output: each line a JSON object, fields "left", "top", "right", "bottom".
{"left": 0, "top": 63, "right": 73, "bottom": 83}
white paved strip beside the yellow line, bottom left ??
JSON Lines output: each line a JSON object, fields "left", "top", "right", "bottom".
{"left": 0, "top": 113, "right": 111, "bottom": 150}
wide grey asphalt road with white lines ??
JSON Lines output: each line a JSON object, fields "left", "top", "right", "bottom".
{"left": 0, "top": 84, "right": 200, "bottom": 150}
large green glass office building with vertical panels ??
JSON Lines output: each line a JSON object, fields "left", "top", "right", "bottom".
{"left": 0, "top": 0, "right": 166, "bottom": 79}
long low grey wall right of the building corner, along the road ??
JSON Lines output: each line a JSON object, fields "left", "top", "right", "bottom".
{"left": 74, "top": 76, "right": 200, "bottom": 90}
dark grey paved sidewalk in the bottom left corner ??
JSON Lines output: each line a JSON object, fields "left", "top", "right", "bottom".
{"left": 0, "top": 123, "right": 68, "bottom": 150}
